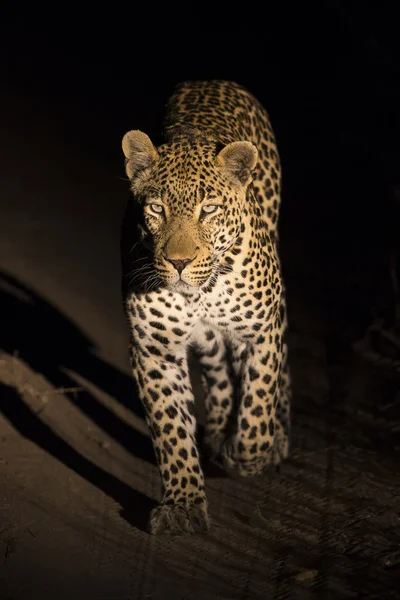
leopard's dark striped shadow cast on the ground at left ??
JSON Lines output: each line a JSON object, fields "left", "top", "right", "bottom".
{"left": 0, "top": 273, "right": 159, "bottom": 529}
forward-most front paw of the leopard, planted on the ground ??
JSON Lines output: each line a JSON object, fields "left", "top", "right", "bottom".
{"left": 149, "top": 502, "right": 210, "bottom": 535}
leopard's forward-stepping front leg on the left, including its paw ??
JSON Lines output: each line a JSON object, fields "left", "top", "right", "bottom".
{"left": 131, "top": 342, "right": 209, "bottom": 535}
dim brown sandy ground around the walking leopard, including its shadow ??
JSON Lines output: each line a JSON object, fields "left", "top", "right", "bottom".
{"left": 0, "top": 85, "right": 400, "bottom": 600}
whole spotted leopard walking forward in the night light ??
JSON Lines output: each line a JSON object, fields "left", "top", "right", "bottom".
{"left": 122, "top": 80, "right": 291, "bottom": 535}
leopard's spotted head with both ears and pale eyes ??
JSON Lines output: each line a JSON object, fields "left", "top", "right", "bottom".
{"left": 122, "top": 131, "right": 257, "bottom": 287}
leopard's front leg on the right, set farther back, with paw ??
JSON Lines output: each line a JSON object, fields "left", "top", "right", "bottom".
{"left": 222, "top": 322, "right": 288, "bottom": 476}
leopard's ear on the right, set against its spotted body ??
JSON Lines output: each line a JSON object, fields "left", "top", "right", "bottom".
{"left": 216, "top": 142, "right": 258, "bottom": 187}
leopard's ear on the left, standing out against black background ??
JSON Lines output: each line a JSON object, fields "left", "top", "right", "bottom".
{"left": 122, "top": 130, "right": 158, "bottom": 179}
